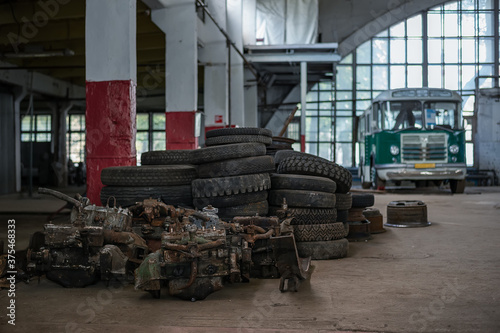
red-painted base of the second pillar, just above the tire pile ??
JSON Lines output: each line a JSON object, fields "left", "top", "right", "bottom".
{"left": 165, "top": 111, "right": 198, "bottom": 150}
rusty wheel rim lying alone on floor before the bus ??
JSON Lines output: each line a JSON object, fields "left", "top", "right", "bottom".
{"left": 385, "top": 200, "right": 431, "bottom": 228}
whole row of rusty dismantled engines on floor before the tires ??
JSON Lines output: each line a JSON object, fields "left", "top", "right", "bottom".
{"left": 26, "top": 188, "right": 311, "bottom": 300}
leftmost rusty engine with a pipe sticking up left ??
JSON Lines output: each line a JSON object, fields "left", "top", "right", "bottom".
{"left": 26, "top": 188, "right": 149, "bottom": 287}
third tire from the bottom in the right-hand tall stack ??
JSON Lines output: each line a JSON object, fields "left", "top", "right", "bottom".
{"left": 268, "top": 206, "right": 337, "bottom": 225}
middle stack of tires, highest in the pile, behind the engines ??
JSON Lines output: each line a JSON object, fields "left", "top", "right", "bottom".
{"left": 192, "top": 127, "right": 275, "bottom": 220}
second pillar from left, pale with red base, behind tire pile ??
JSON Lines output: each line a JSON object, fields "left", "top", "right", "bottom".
{"left": 151, "top": 0, "right": 199, "bottom": 149}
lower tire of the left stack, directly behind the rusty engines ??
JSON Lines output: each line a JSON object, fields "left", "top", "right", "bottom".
{"left": 101, "top": 185, "right": 193, "bottom": 207}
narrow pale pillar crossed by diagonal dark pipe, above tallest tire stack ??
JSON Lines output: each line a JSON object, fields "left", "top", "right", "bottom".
{"left": 227, "top": 0, "right": 246, "bottom": 126}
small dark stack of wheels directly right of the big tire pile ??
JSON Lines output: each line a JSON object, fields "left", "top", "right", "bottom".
{"left": 347, "top": 193, "right": 375, "bottom": 242}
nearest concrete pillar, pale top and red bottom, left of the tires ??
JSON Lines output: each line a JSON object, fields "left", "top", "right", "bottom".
{"left": 85, "top": 0, "right": 137, "bottom": 204}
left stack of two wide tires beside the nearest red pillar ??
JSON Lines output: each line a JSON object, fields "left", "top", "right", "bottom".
{"left": 101, "top": 161, "right": 198, "bottom": 207}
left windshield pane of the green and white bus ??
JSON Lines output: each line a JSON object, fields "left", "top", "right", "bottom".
{"left": 378, "top": 101, "right": 422, "bottom": 130}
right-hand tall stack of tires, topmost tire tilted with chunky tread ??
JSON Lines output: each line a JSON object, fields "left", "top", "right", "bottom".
{"left": 269, "top": 151, "right": 352, "bottom": 260}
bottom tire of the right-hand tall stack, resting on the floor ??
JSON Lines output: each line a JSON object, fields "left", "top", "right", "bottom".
{"left": 296, "top": 238, "right": 349, "bottom": 260}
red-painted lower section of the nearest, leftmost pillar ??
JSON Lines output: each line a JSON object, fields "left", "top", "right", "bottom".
{"left": 85, "top": 80, "right": 136, "bottom": 205}
